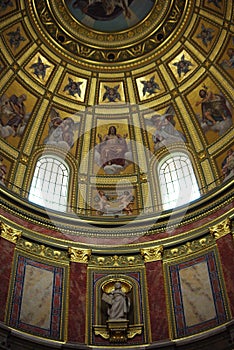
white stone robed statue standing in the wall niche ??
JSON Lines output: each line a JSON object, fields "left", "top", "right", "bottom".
{"left": 102, "top": 281, "right": 131, "bottom": 320}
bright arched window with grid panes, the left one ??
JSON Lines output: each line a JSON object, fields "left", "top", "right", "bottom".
{"left": 28, "top": 156, "right": 69, "bottom": 211}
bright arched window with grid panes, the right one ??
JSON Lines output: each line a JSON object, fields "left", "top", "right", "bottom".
{"left": 158, "top": 153, "right": 200, "bottom": 210}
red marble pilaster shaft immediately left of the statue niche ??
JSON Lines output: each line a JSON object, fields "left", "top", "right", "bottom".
{"left": 68, "top": 263, "right": 87, "bottom": 343}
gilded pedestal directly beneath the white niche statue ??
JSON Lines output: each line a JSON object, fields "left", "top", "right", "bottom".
{"left": 106, "top": 319, "right": 129, "bottom": 343}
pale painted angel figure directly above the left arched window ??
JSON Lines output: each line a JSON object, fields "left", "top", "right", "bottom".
{"left": 44, "top": 108, "right": 77, "bottom": 150}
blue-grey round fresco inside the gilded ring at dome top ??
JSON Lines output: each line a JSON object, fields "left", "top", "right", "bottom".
{"left": 65, "top": 0, "right": 155, "bottom": 32}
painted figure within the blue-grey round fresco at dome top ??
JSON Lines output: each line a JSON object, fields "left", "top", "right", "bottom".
{"left": 72, "top": 0, "right": 131, "bottom": 20}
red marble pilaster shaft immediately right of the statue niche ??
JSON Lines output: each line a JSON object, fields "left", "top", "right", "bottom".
{"left": 146, "top": 261, "right": 169, "bottom": 342}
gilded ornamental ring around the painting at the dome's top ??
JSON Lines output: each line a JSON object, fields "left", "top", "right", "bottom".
{"left": 31, "top": 0, "right": 188, "bottom": 63}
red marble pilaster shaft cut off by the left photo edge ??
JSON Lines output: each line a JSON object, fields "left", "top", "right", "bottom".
{"left": 0, "top": 238, "right": 15, "bottom": 321}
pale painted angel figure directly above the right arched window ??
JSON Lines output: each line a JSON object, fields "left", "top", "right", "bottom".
{"left": 146, "top": 106, "right": 186, "bottom": 151}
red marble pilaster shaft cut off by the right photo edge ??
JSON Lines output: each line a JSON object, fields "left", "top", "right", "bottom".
{"left": 217, "top": 234, "right": 234, "bottom": 317}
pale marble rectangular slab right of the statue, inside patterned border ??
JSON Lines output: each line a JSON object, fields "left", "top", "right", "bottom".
{"left": 179, "top": 262, "right": 216, "bottom": 327}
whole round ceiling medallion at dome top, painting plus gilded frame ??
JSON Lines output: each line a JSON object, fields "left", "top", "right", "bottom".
{"left": 29, "top": 0, "right": 190, "bottom": 68}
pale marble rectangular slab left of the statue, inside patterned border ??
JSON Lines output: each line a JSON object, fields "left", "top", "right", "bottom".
{"left": 20, "top": 265, "right": 54, "bottom": 329}
